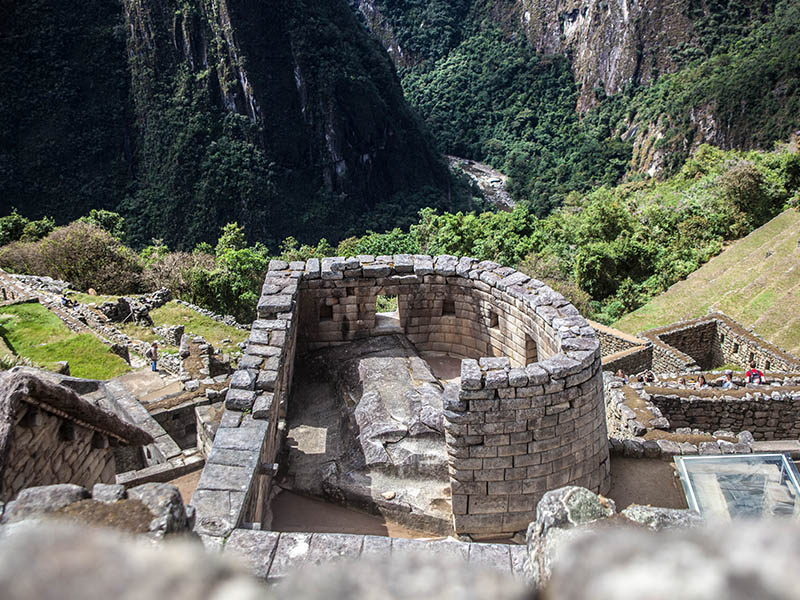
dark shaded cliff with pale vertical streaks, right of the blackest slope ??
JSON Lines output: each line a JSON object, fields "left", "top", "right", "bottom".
{"left": 125, "top": 0, "right": 449, "bottom": 242}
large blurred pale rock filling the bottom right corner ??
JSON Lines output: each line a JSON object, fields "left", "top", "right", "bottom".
{"left": 547, "top": 521, "right": 800, "bottom": 600}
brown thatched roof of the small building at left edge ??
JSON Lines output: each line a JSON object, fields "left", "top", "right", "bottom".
{"left": 0, "top": 369, "right": 154, "bottom": 482}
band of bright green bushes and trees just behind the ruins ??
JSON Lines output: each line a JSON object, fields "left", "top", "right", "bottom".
{"left": 0, "top": 143, "right": 800, "bottom": 322}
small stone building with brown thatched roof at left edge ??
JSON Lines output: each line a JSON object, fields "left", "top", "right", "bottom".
{"left": 0, "top": 369, "right": 153, "bottom": 502}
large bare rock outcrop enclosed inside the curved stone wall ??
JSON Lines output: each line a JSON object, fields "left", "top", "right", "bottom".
{"left": 286, "top": 335, "right": 451, "bottom": 532}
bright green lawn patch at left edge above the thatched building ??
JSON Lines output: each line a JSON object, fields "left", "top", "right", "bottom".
{"left": 0, "top": 303, "right": 130, "bottom": 379}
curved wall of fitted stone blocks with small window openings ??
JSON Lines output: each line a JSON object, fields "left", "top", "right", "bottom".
{"left": 193, "top": 255, "right": 609, "bottom": 535}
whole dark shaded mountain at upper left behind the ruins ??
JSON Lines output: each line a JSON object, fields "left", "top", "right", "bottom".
{"left": 0, "top": 0, "right": 458, "bottom": 248}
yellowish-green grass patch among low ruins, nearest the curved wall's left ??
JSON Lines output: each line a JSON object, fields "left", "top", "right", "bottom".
{"left": 119, "top": 302, "right": 249, "bottom": 352}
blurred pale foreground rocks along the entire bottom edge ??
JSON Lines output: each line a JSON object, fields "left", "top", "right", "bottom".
{"left": 0, "top": 506, "right": 800, "bottom": 600}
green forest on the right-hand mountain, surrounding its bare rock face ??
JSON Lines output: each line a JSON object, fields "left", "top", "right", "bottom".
{"left": 368, "top": 0, "right": 800, "bottom": 216}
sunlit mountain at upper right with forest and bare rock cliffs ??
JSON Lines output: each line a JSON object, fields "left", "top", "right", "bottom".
{"left": 351, "top": 0, "right": 800, "bottom": 215}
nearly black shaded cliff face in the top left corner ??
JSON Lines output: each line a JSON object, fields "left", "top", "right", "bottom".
{"left": 0, "top": 0, "right": 132, "bottom": 220}
